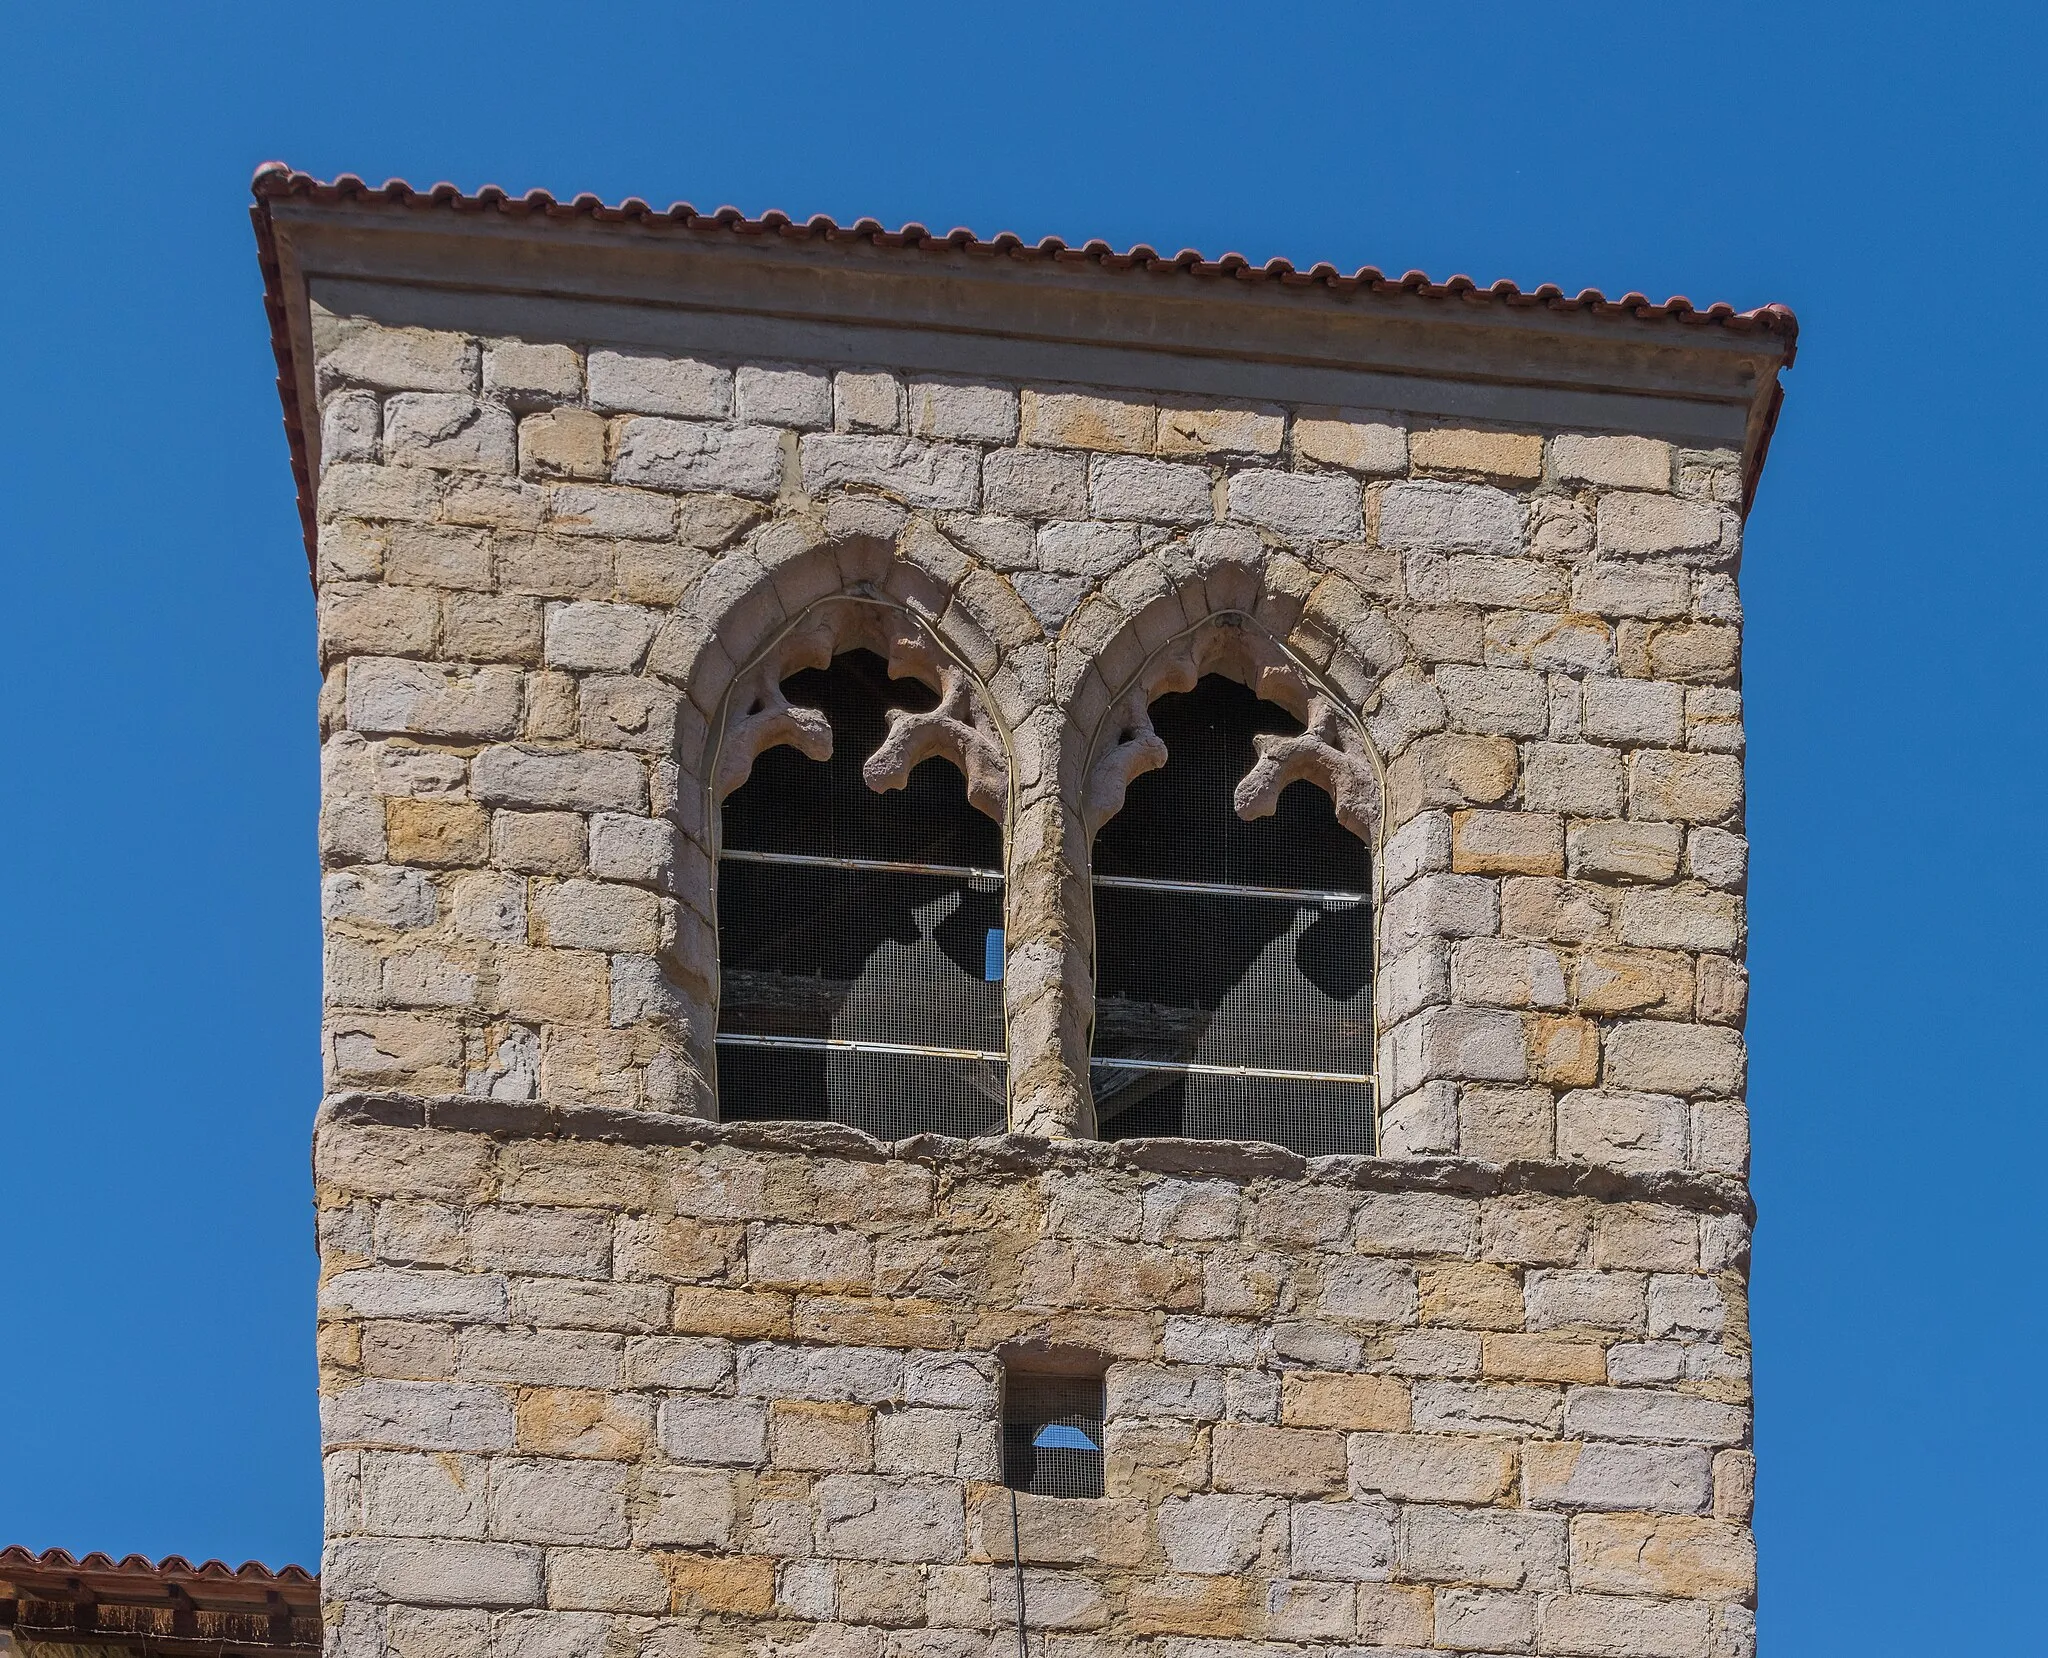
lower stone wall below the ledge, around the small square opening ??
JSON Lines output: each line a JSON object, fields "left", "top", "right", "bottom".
{"left": 317, "top": 1099, "right": 1755, "bottom": 1658}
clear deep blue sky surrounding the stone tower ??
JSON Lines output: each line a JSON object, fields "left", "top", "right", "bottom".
{"left": 0, "top": 0, "right": 2048, "bottom": 1658}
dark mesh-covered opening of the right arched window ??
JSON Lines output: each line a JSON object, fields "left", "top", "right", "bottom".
{"left": 1090, "top": 675, "right": 1374, "bottom": 1157}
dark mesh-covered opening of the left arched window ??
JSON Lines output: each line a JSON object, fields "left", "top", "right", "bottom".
{"left": 719, "top": 651, "right": 1004, "bottom": 1140}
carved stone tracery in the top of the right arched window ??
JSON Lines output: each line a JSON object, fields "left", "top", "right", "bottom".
{"left": 1081, "top": 614, "right": 1380, "bottom": 845}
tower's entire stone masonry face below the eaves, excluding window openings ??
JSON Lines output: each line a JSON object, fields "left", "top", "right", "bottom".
{"left": 313, "top": 309, "right": 1755, "bottom": 1658}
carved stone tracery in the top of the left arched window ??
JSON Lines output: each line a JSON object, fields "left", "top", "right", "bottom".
{"left": 711, "top": 598, "right": 1010, "bottom": 823}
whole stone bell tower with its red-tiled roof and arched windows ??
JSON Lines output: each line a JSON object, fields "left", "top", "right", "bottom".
{"left": 254, "top": 166, "right": 1794, "bottom": 1658}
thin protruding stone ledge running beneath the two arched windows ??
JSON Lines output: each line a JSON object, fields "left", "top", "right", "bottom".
{"left": 315, "top": 1091, "right": 1755, "bottom": 1222}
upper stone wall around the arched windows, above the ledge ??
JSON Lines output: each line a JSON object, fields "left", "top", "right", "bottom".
{"left": 315, "top": 315, "right": 1747, "bottom": 1173}
